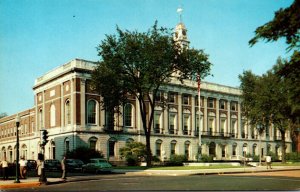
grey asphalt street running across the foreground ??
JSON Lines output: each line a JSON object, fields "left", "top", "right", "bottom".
{"left": 3, "top": 170, "right": 300, "bottom": 191}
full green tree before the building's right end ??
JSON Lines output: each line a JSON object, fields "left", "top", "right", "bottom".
{"left": 239, "top": 58, "right": 292, "bottom": 163}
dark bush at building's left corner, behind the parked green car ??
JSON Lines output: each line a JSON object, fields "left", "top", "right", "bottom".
{"left": 67, "top": 147, "right": 104, "bottom": 163}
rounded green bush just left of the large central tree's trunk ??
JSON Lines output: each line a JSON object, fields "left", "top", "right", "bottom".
{"left": 120, "top": 141, "right": 147, "bottom": 166}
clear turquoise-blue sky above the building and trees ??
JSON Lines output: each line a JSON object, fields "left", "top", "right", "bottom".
{"left": 0, "top": 0, "right": 293, "bottom": 115}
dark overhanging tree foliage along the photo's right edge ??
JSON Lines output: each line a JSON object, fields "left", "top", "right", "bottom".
{"left": 249, "top": 0, "right": 300, "bottom": 158}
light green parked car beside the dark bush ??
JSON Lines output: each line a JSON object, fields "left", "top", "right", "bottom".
{"left": 82, "top": 158, "right": 112, "bottom": 173}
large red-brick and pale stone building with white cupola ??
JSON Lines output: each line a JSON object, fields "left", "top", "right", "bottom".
{"left": 0, "top": 23, "right": 292, "bottom": 162}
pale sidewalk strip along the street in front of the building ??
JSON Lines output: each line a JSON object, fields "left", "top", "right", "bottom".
{"left": 0, "top": 166, "right": 300, "bottom": 189}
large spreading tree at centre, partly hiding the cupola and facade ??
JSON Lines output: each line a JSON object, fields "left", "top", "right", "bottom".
{"left": 92, "top": 22, "right": 211, "bottom": 166}
